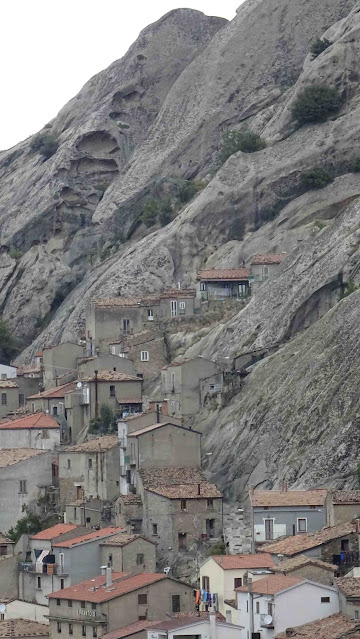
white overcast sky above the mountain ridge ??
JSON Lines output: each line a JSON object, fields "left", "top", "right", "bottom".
{"left": 0, "top": 0, "right": 243, "bottom": 149}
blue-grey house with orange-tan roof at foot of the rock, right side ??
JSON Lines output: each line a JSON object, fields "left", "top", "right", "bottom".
{"left": 250, "top": 483, "right": 327, "bottom": 543}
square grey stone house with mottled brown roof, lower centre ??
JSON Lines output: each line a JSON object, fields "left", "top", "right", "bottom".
{"left": 136, "top": 467, "right": 223, "bottom": 552}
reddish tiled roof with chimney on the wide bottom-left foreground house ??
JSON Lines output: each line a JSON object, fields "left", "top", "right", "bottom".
{"left": 48, "top": 572, "right": 168, "bottom": 603}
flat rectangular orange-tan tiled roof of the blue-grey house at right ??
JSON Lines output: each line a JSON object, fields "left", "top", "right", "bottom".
{"left": 250, "top": 489, "right": 327, "bottom": 507}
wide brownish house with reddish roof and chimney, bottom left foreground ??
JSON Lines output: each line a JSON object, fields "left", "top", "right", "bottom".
{"left": 49, "top": 568, "right": 194, "bottom": 639}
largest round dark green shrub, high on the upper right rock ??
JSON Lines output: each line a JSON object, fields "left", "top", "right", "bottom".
{"left": 292, "top": 85, "right": 342, "bottom": 125}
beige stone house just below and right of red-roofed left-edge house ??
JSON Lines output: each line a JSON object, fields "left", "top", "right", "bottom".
{"left": 59, "top": 435, "right": 120, "bottom": 505}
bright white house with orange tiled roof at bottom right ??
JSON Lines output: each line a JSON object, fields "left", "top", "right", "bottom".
{"left": 234, "top": 575, "right": 339, "bottom": 639}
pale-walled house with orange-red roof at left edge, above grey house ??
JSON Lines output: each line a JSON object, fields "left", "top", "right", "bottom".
{"left": 0, "top": 413, "right": 60, "bottom": 450}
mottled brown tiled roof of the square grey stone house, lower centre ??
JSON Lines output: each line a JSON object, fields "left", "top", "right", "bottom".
{"left": 139, "top": 468, "right": 222, "bottom": 499}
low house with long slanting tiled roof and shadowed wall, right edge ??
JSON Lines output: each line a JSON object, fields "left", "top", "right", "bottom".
{"left": 258, "top": 520, "right": 359, "bottom": 573}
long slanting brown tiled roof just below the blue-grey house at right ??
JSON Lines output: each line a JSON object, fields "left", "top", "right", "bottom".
{"left": 259, "top": 521, "right": 357, "bottom": 557}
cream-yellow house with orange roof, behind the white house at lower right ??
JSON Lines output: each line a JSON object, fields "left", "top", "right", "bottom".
{"left": 200, "top": 553, "right": 275, "bottom": 615}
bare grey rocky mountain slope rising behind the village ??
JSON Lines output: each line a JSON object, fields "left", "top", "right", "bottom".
{"left": 0, "top": 0, "right": 360, "bottom": 499}
